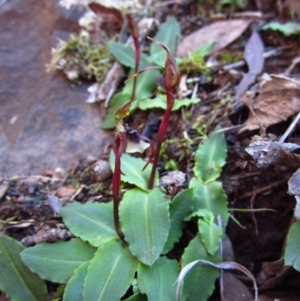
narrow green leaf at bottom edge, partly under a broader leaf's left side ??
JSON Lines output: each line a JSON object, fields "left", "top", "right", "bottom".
{"left": 63, "top": 261, "right": 90, "bottom": 301}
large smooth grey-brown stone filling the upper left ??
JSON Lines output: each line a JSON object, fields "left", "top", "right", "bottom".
{"left": 0, "top": 0, "right": 112, "bottom": 177}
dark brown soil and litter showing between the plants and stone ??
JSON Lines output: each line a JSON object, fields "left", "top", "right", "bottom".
{"left": 0, "top": 0, "right": 300, "bottom": 301}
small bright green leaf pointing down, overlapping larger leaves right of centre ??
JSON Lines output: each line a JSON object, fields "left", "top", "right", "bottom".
{"left": 198, "top": 218, "right": 223, "bottom": 255}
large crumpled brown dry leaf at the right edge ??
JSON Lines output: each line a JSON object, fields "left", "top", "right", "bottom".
{"left": 239, "top": 75, "right": 300, "bottom": 133}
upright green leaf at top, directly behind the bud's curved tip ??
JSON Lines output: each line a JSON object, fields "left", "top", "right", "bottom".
{"left": 150, "top": 17, "right": 180, "bottom": 68}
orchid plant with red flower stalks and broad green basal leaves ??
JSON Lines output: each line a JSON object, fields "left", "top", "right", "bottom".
{"left": 0, "top": 15, "right": 258, "bottom": 301}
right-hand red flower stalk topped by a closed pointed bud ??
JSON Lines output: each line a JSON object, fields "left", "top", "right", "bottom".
{"left": 148, "top": 37, "right": 180, "bottom": 189}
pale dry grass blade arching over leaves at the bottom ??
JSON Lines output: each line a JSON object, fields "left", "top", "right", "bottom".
{"left": 176, "top": 259, "right": 258, "bottom": 301}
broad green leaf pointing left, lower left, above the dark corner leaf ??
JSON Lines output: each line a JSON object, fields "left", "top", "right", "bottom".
{"left": 21, "top": 238, "right": 96, "bottom": 283}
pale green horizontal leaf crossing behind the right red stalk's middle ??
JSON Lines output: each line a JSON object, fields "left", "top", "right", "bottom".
{"left": 138, "top": 94, "right": 200, "bottom": 111}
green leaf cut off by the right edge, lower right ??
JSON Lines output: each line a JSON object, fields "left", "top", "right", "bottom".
{"left": 284, "top": 221, "right": 300, "bottom": 272}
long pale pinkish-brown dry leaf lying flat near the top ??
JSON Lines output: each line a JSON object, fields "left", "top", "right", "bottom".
{"left": 176, "top": 19, "right": 252, "bottom": 57}
